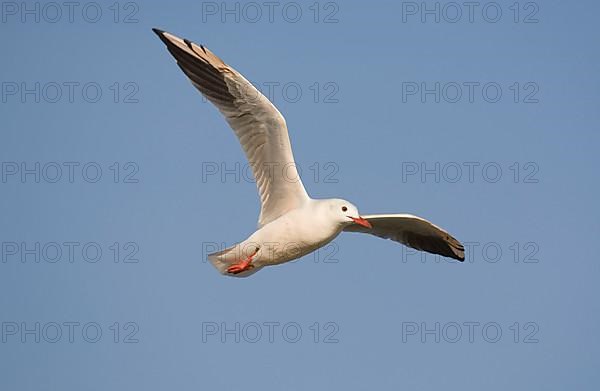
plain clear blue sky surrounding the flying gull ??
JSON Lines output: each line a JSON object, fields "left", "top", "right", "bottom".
{"left": 0, "top": 1, "right": 600, "bottom": 391}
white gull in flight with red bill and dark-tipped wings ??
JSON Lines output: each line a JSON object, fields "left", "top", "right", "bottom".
{"left": 153, "top": 29, "right": 465, "bottom": 277}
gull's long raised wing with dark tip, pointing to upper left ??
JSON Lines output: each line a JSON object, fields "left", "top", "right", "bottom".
{"left": 153, "top": 29, "right": 308, "bottom": 227}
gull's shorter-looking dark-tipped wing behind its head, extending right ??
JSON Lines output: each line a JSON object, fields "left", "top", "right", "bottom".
{"left": 344, "top": 214, "right": 465, "bottom": 261}
